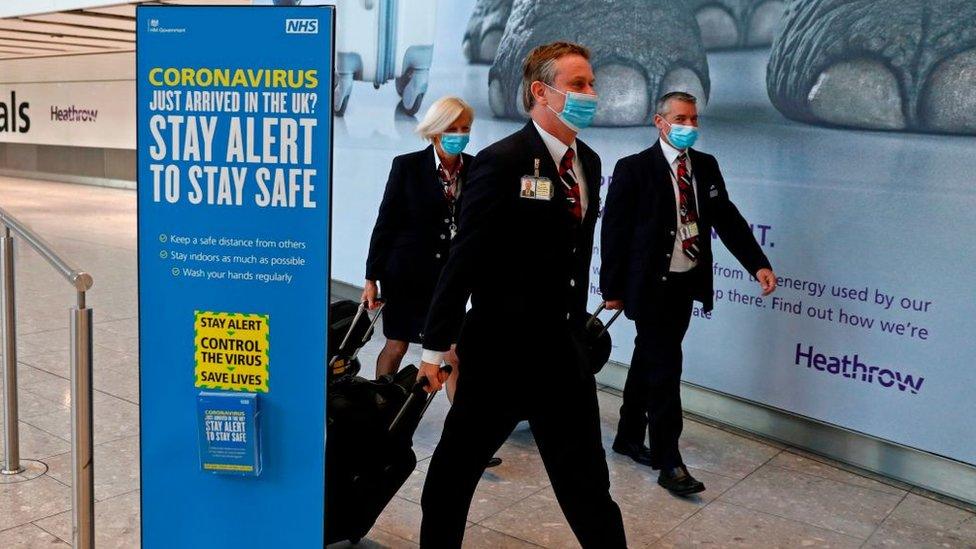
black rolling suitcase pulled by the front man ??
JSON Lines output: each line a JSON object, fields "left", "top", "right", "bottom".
{"left": 325, "top": 365, "right": 452, "bottom": 545}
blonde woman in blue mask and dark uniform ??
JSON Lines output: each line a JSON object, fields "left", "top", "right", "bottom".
{"left": 362, "top": 97, "right": 474, "bottom": 386}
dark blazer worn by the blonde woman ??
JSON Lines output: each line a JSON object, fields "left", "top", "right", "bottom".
{"left": 366, "top": 145, "right": 473, "bottom": 288}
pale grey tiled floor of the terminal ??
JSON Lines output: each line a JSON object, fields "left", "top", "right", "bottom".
{"left": 0, "top": 178, "right": 976, "bottom": 549}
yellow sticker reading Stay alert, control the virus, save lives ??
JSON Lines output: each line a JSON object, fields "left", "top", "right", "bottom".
{"left": 193, "top": 311, "right": 271, "bottom": 393}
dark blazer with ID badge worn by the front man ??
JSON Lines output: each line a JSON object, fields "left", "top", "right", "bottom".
{"left": 424, "top": 121, "right": 600, "bottom": 351}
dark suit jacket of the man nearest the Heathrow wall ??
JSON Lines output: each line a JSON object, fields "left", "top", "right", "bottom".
{"left": 600, "top": 140, "right": 770, "bottom": 319}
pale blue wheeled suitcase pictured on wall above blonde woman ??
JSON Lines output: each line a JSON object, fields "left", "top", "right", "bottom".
{"left": 333, "top": 0, "right": 437, "bottom": 116}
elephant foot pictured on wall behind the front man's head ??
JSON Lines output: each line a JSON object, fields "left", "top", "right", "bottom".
{"left": 488, "top": 0, "right": 709, "bottom": 126}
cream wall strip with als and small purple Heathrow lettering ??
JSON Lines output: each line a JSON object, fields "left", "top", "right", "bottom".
{"left": 0, "top": 52, "right": 136, "bottom": 188}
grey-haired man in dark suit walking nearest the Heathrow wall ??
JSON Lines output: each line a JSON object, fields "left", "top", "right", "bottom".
{"left": 600, "top": 92, "right": 776, "bottom": 495}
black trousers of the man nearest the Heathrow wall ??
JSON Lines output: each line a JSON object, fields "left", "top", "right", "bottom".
{"left": 617, "top": 272, "right": 694, "bottom": 469}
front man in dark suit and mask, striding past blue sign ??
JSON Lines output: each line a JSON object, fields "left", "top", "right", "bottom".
{"left": 420, "top": 42, "right": 626, "bottom": 548}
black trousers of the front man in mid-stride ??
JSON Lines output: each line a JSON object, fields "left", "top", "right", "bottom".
{"left": 420, "top": 326, "right": 627, "bottom": 549}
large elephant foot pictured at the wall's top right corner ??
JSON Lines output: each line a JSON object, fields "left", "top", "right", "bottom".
{"left": 767, "top": 0, "right": 976, "bottom": 134}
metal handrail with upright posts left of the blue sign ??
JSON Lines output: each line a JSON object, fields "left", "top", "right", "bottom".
{"left": 0, "top": 208, "right": 95, "bottom": 549}
